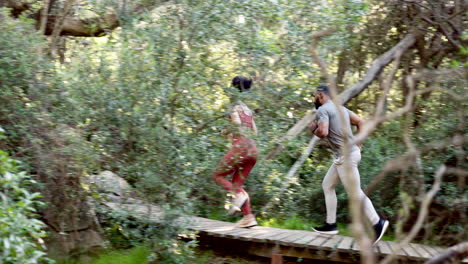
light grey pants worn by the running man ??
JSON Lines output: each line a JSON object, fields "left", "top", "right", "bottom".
{"left": 322, "top": 150, "right": 379, "bottom": 225}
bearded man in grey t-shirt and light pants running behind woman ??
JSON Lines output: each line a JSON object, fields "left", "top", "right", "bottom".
{"left": 310, "top": 86, "right": 389, "bottom": 244}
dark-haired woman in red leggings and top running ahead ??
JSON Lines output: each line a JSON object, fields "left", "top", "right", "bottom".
{"left": 213, "top": 76, "right": 258, "bottom": 227}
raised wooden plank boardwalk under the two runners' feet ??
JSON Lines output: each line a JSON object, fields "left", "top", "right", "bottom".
{"left": 104, "top": 199, "right": 468, "bottom": 263}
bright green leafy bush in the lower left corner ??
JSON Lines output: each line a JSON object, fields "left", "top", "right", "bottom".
{"left": 0, "top": 145, "right": 48, "bottom": 264}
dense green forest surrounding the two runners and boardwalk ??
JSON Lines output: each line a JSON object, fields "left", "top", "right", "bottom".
{"left": 0, "top": 0, "right": 468, "bottom": 264}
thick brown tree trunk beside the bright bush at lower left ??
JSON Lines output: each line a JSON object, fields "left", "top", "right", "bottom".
{"left": 27, "top": 124, "right": 104, "bottom": 259}
